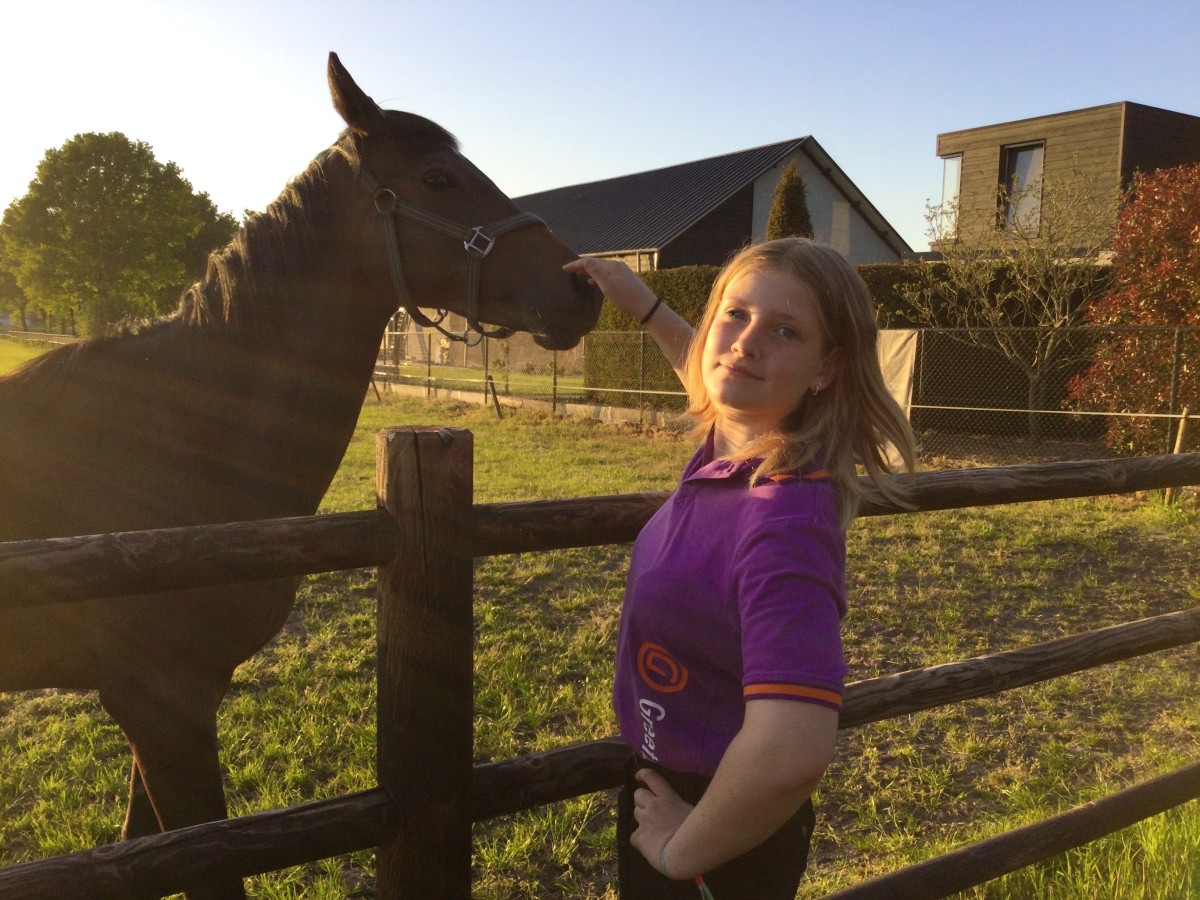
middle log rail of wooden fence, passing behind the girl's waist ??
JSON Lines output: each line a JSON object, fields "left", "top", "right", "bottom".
{"left": 0, "top": 607, "right": 1200, "bottom": 900}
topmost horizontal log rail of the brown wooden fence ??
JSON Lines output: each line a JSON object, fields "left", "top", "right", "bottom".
{"left": 9, "top": 454, "right": 1200, "bottom": 608}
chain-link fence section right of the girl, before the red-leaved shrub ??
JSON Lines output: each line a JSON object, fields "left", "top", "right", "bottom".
{"left": 911, "top": 328, "right": 1200, "bottom": 460}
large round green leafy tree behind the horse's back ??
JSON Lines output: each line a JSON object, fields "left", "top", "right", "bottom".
{"left": 2, "top": 132, "right": 236, "bottom": 334}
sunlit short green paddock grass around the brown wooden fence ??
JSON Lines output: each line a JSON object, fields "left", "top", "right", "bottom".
{"left": 0, "top": 391, "right": 1200, "bottom": 900}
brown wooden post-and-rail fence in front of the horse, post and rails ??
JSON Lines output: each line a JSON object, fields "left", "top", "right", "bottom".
{"left": 0, "top": 428, "right": 1200, "bottom": 900}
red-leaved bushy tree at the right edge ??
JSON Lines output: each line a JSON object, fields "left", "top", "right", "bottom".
{"left": 1070, "top": 163, "right": 1200, "bottom": 454}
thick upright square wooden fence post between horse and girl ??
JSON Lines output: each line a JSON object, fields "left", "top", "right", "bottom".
{"left": 376, "top": 427, "right": 474, "bottom": 900}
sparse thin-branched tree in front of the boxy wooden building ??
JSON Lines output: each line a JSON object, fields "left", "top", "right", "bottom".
{"left": 901, "top": 163, "right": 1120, "bottom": 438}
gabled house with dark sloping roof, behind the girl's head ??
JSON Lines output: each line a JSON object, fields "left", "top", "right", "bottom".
{"left": 515, "top": 137, "right": 912, "bottom": 271}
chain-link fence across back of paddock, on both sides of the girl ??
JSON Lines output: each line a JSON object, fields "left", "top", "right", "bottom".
{"left": 376, "top": 325, "right": 1200, "bottom": 463}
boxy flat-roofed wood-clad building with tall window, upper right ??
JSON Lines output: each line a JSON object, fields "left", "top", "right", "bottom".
{"left": 937, "top": 101, "right": 1200, "bottom": 238}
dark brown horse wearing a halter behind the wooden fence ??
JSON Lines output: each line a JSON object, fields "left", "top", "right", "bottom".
{"left": 0, "top": 54, "right": 600, "bottom": 898}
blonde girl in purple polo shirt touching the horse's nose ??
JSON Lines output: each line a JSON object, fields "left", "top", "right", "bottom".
{"left": 565, "top": 239, "right": 916, "bottom": 900}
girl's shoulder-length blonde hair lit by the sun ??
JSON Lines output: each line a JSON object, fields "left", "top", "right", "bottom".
{"left": 684, "top": 238, "right": 917, "bottom": 527}
